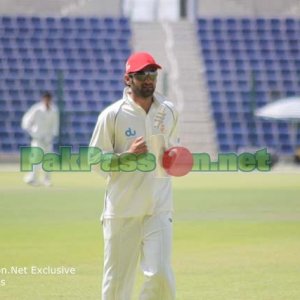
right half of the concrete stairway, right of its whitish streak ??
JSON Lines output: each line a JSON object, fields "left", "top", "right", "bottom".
{"left": 170, "top": 21, "right": 217, "bottom": 155}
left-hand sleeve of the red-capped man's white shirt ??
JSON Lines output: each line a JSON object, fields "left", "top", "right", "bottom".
{"left": 89, "top": 111, "right": 115, "bottom": 178}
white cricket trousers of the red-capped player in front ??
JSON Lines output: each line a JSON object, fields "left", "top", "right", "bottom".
{"left": 102, "top": 212, "right": 175, "bottom": 300}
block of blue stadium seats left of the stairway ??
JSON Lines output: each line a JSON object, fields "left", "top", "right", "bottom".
{"left": 0, "top": 16, "right": 131, "bottom": 152}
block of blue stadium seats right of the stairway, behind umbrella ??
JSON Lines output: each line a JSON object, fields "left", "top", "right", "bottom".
{"left": 197, "top": 18, "right": 300, "bottom": 154}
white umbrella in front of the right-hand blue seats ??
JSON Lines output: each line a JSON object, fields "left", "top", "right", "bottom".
{"left": 255, "top": 97, "right": 300, "bottom": 122}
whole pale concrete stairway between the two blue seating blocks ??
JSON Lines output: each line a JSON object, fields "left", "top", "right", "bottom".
{"left": 133, "top": 21, "right": 217, "bottom": 157}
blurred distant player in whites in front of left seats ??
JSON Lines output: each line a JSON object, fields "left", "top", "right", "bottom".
{"left": 22, "top": 92, "right": 59, "bottom": 186}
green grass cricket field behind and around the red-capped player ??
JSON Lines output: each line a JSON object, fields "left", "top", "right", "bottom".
{"left": 0, "top": 172, "right": 300, "bottom": 300}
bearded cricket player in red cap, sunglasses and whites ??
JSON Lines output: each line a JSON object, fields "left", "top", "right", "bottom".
{"left": 90, "top": 52, "right": 179, "bottom": 300}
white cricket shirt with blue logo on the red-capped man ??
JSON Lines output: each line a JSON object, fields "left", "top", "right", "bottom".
{"left": 90, "top": 88, "right": 179, "bottom": 218}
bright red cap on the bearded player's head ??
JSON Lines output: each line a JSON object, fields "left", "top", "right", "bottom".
{"left": 126, "top": 52, "right": 161, "bottom": 74}
